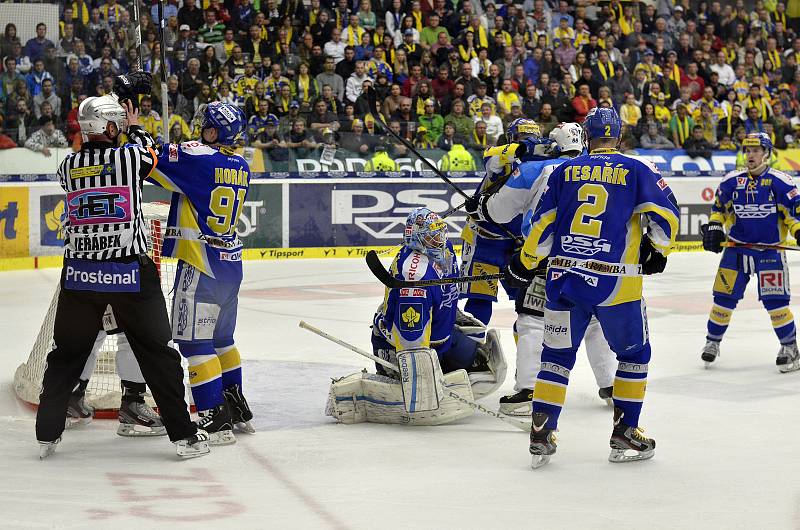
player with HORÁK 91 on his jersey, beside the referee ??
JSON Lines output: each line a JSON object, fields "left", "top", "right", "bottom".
{"left": 145, "top": 102, "right": 255, "bottom": 445}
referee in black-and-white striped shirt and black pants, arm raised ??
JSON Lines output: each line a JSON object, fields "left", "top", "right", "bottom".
{"left": 36, "top": 72, "right": 209, "bottom": 458}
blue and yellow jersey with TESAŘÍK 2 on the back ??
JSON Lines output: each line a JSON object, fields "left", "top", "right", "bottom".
{"left": 521, "top": 149, "right": 679, "bottom": 306}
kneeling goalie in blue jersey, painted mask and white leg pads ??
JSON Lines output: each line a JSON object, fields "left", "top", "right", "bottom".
{"left": 326, "top": 208, "right": 506, "bottom": 425}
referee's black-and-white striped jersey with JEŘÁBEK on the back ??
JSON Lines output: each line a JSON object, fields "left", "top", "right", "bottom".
{"left": 58, "top": 126, "right": 158, "bottom": 261}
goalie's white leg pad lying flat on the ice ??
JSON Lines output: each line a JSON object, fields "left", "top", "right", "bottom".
{"left": 325, "top": 370, "right": 474, "bottom": 425}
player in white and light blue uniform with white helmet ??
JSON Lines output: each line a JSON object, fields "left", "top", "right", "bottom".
{"left": 474, "top": 123, "right": 617, "bottom": 416}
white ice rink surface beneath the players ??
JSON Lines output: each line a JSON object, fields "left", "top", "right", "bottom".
{"left": 0, "top": 253, "right": 800, "bottom": 530}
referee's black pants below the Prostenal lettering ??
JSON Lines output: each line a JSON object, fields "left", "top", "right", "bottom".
{"left": 36, "top": 257, "right": 197, "bottom": 442}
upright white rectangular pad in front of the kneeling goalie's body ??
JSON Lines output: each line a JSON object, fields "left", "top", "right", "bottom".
{"left": 397, "top": 348, "right": 444, "bottom": 413}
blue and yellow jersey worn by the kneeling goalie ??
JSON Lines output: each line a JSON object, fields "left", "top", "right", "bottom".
{"left": 373, "top": 241, "right": 458, "bottom": 354}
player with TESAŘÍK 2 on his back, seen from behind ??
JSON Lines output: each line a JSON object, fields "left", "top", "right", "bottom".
{"left": 506, "top": 108, "right": 678, "bottom": 468}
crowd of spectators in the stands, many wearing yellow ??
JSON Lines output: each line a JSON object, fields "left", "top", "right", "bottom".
{"left": 0, "top": 0, "right": 800, "bottom": 165}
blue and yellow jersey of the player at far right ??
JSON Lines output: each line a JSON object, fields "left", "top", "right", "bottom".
{"left": 710, "top": 169, "right": 800, "bottom": 245}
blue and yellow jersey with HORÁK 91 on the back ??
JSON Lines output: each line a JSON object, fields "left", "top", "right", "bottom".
{"left": 148, "top": 141, "right": 250, "bottom": 282}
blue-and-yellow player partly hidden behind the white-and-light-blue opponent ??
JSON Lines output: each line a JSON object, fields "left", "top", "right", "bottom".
{"left": 461, "top": 118, "right": 551, "bottom": 326}
